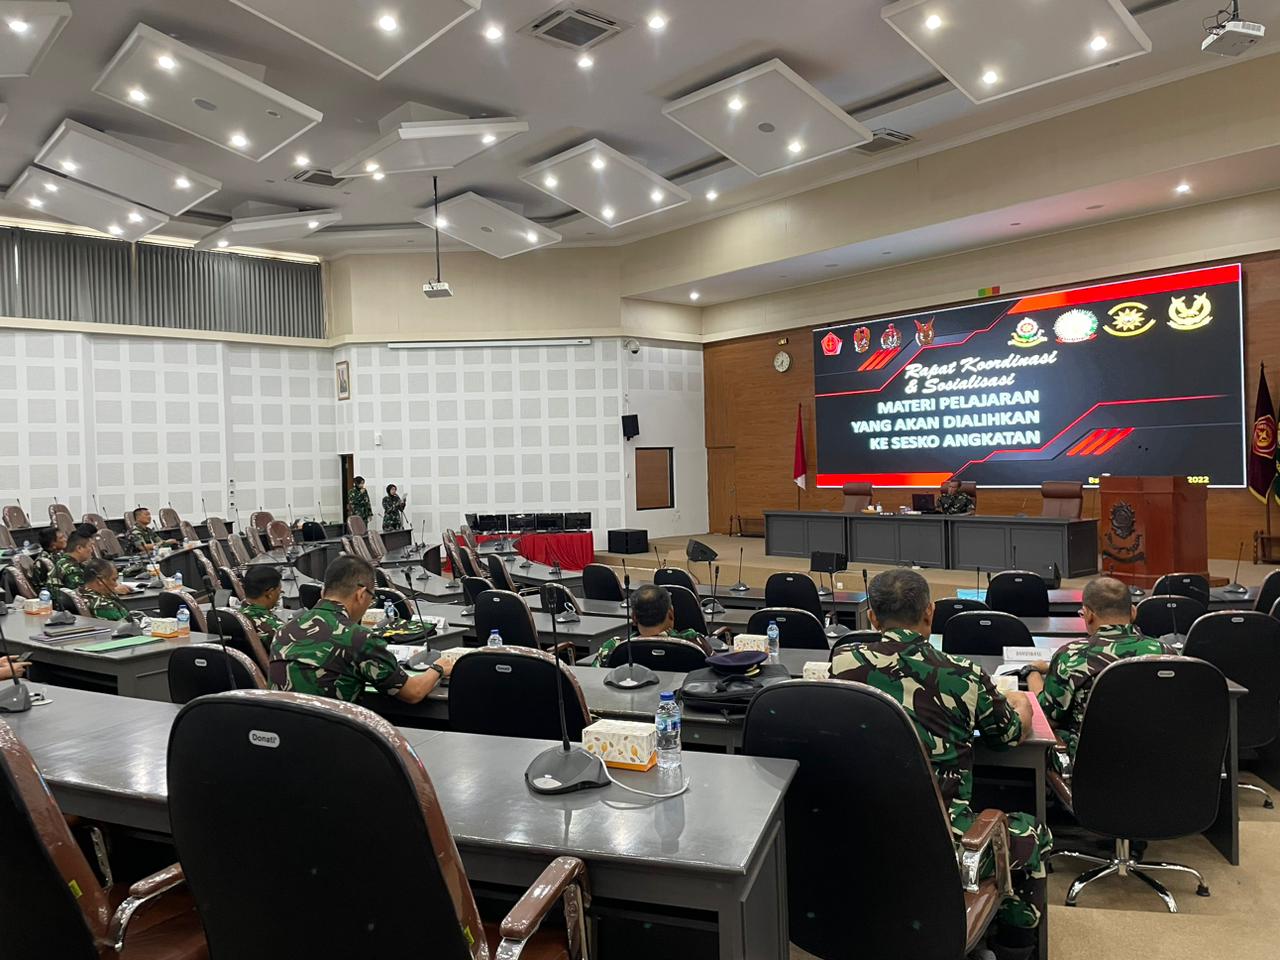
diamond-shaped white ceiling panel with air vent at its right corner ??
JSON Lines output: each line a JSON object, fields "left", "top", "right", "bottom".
{"left": 662, "top": 60, "right": 872, "bottom": 177}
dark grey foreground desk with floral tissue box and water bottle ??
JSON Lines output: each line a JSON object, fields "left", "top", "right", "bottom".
{"left": 4, "top": 686, "right": 796, "bottom": 960}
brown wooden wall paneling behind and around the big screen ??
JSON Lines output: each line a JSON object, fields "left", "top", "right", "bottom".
{"left": 703, "top": 251, "right": 1280, "bottom": 558}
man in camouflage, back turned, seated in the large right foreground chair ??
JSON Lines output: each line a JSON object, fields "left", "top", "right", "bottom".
{"left": 831, "top": 570, "right": 1052, "bottom": 960}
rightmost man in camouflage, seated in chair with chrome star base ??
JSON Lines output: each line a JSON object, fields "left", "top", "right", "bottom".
{"left": 1027, "top": 577, "right": 1174, "bottom": 773}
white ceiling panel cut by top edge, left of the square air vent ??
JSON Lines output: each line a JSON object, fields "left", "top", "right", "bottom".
{"left": 232, "top": 0, "right": 480, "bottom": 79}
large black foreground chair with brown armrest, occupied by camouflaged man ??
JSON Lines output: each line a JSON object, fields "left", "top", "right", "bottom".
{"left": 742, "top": 680, "right": 1012, "bottom": 960}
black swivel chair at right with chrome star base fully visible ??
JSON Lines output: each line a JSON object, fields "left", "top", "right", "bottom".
{"left": 1049, "top": 657, "right": 1228, "bottom": 913}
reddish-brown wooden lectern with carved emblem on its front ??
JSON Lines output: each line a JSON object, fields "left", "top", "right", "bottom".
{"left": 1098, "top": 476, "right": 1208, "bottom": 588}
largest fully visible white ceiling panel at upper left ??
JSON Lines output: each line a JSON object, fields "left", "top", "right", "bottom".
{"left": 93, "top": 23, "right": 324, "bottom": 160}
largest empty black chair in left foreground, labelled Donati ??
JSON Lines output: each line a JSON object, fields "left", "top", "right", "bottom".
{"left": 165, "top": 691, "right": 589, "bottom": 960}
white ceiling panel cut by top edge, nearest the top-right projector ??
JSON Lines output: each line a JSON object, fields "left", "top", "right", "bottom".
{"left": 881, "top": 0, "right": 1151, "bottom": 104}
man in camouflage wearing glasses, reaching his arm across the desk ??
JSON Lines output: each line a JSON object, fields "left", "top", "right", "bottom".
{"left": 269, "top": 554, "right": 453, "bottom": 703}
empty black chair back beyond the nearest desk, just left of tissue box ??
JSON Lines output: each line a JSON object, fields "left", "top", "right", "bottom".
{"left": 449, "top": 647, "right": 591, "bottom": 740}
